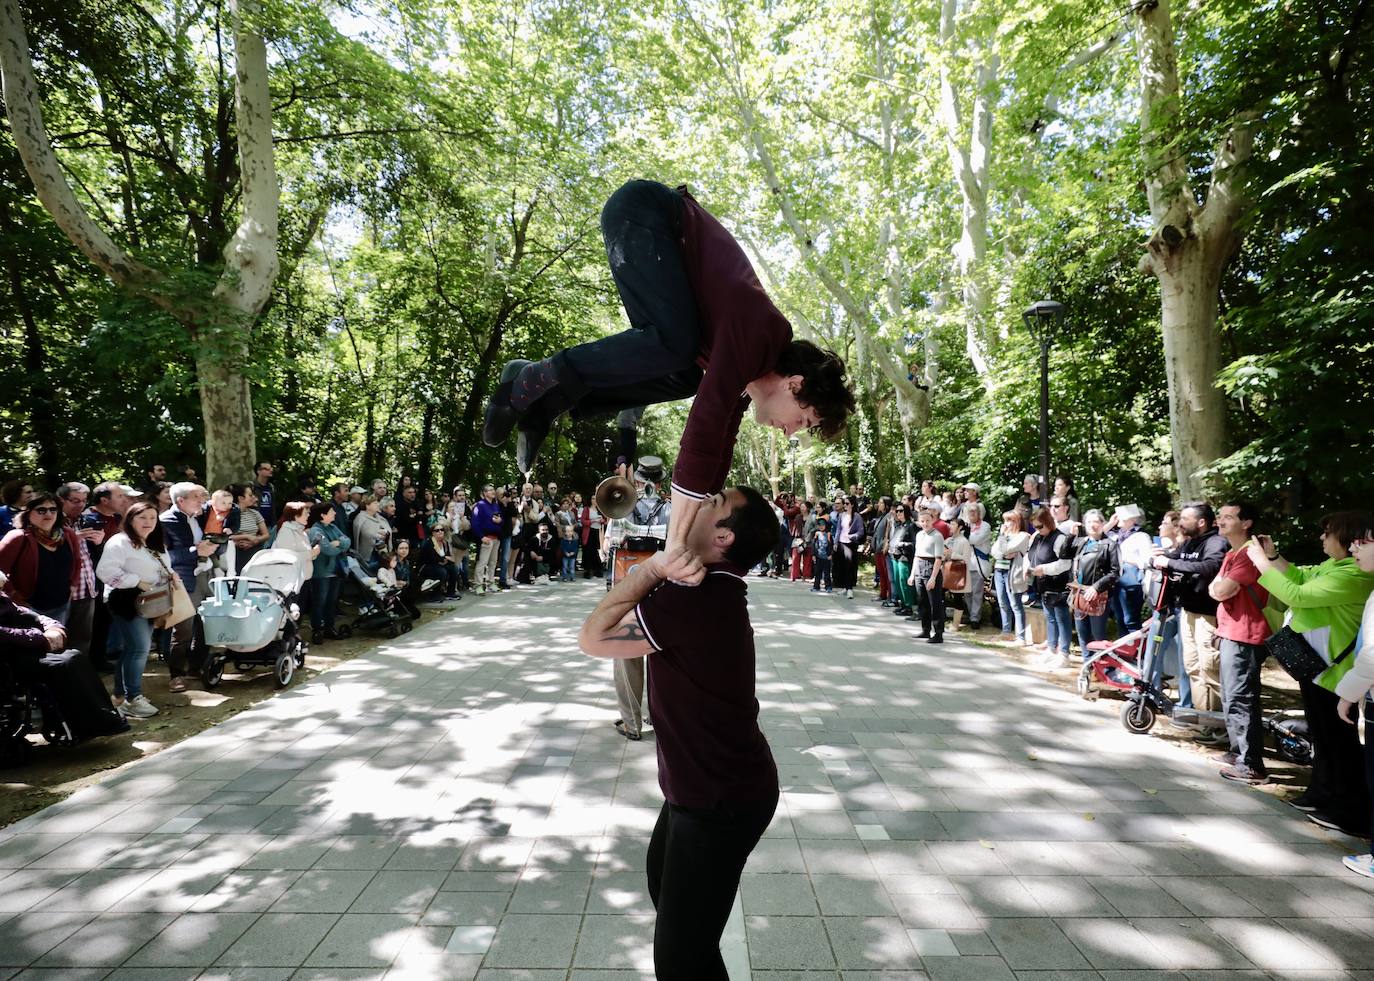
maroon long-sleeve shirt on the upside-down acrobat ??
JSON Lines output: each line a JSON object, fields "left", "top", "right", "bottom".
{"left": 673, "top": 192, "right": 791, "bottom": 500}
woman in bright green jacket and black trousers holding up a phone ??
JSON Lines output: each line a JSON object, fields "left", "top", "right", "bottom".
{"left": 1246, "top": 511, "right": 1374, "bottom": 837}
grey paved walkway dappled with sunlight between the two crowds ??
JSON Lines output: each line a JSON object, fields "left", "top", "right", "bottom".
{"left": 0, "top": 580, "right": 1374, "bottom": 981}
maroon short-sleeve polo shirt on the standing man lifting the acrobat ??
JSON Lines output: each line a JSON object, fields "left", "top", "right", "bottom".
{"left": 635, "top": 565, "right": 778, "bottom": 808}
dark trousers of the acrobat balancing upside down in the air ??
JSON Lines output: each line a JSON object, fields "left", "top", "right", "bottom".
{"left": 554, "top": 180, "right": 702, "bottom": 420}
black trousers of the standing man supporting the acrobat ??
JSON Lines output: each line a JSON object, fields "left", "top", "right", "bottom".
{"left": 647, "top": 791, "right": 778, "bottom": 981}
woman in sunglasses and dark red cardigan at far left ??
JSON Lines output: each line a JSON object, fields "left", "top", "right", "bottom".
{"left": 0, "top": 491, "right": 85, "bottom": 627}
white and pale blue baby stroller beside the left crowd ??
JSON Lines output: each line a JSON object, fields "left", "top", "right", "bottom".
{"left": 201, "top": 548, "right": 306, "bottom": 688}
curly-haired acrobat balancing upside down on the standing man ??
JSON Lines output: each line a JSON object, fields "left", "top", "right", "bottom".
{"left": 482, "top": 180, "right": 855, "bottom": 583}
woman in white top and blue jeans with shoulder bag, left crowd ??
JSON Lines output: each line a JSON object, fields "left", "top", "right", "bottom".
{"left": 95, "top": 501, "right": 172, "bottom": 719}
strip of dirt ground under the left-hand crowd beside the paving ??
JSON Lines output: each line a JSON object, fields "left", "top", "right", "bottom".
{"left": 0, "top": 606, "right": 458, "bottom": 827}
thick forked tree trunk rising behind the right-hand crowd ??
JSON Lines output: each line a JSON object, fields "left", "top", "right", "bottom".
{"left": 1134, "top": 0, "right": 1253, "bottom": 500}
